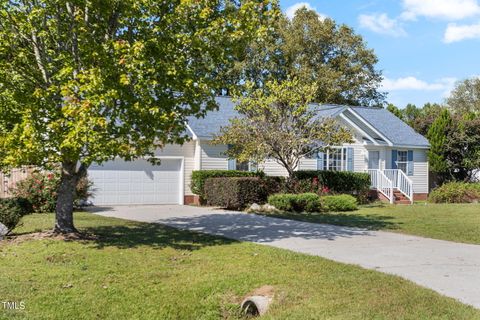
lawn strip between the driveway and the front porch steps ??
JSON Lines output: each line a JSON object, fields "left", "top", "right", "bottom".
{"left": 260, "top": 203, "right": 480, "bottom": 244}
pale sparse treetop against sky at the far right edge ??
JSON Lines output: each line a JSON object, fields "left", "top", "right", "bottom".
{"left": 447, "top": 78, "right": 480, "bottom": 116}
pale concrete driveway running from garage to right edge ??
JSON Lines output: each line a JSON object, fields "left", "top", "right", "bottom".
{"left": 91, "top": 206, "right": 480, "bottom": 308}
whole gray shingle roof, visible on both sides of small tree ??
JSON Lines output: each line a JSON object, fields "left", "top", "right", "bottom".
{"left": 188, "top": 97, "right": 429, "bottom": 147}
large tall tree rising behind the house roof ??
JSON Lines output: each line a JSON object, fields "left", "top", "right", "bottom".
{"left": 226, "top": 8, "right": 385, "bottom": 106}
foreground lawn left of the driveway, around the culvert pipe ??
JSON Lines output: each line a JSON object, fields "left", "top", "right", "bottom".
{"left": 0, "top": 213, "right": 480, "bottom": 320}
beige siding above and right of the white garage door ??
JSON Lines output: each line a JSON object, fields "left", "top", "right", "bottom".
{"left": 155, "top": 141, "right": 195, "bottom": 195}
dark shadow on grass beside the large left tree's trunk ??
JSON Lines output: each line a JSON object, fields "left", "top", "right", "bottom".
{"left": 82, "top": 223, "right": 237, "bottom": 251}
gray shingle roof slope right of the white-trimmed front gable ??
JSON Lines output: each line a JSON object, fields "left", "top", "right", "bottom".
{"left": 351, "top": 107, "right": 430, "bottom": 147}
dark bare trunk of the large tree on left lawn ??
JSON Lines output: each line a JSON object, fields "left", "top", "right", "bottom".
{"left": 54, "top": 163, "right": 78, "bottom": 233}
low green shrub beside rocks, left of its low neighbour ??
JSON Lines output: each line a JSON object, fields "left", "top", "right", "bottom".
{"left": 268, "top": 193, "right": 322, "bottom": 212}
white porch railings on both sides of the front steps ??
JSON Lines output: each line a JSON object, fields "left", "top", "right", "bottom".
{"left": 368, "top": 169, "right": 413, "bottom": 203}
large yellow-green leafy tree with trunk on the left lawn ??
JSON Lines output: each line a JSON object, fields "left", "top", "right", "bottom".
{"left": 0, "top": 0, "right": 276, "bottom": 233}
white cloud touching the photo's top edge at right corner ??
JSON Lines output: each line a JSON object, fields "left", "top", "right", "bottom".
{"left": 401, "top": 0, "right": 480, "bottom": 20}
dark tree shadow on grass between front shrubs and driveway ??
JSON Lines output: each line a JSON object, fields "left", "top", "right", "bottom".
{"left": 261, "top": 212, "right": 400, "bottom": 230}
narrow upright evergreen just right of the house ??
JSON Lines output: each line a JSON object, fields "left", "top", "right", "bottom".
{"left": 427, "top": 109, "right": 452, "bottom": 182}
